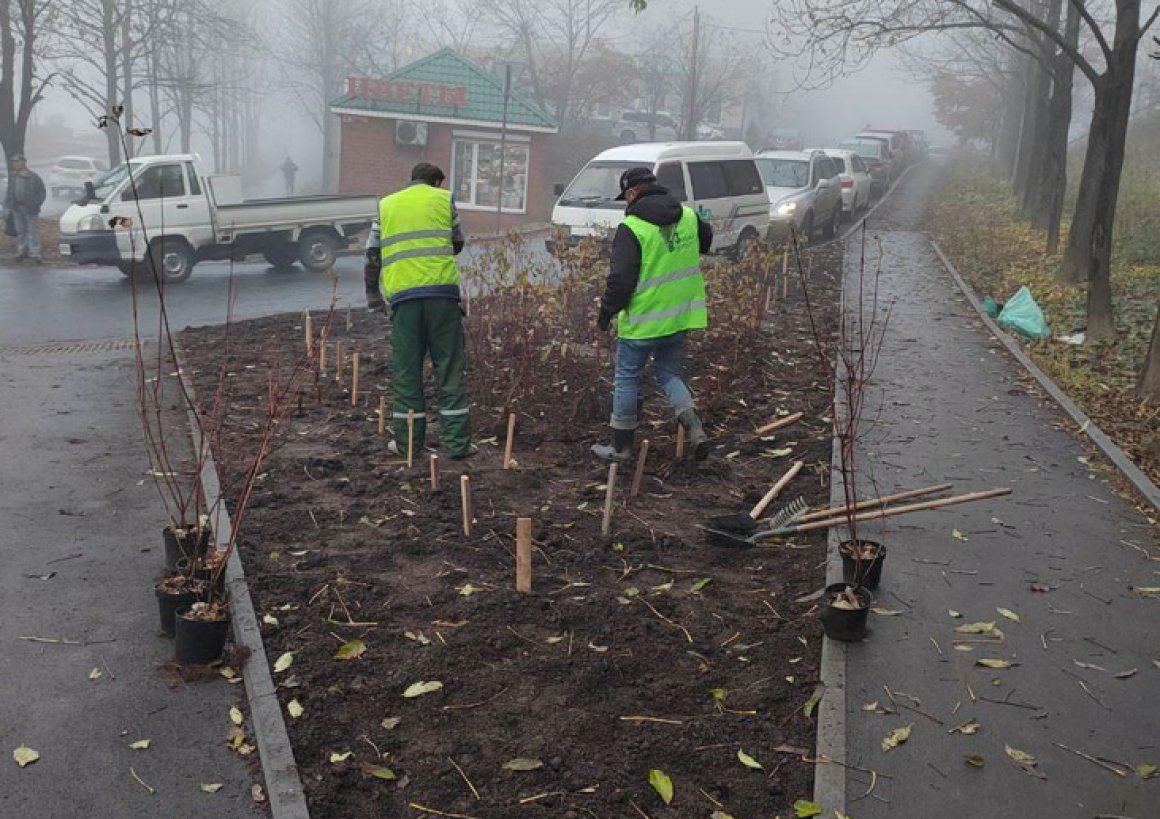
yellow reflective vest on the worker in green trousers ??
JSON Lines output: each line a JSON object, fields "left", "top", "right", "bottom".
{"left": 378, "top": 183, "right": 459, "bottom": 304}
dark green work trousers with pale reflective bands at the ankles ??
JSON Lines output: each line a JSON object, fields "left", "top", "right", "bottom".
{"left": 391, "top": 298, "right": 471, "bottom": 458}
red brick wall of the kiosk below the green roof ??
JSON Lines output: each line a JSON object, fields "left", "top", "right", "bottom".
{"left": 339, "top": 116, "right": 553, "bottom": 235}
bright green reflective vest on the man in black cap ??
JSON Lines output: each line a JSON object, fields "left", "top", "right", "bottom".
{"left": 616, "top": 206, "right": 709, "bottom": 339}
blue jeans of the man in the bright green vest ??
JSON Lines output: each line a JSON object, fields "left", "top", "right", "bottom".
{"left": 610, "top": 333, "right": 693, "bottom": 429}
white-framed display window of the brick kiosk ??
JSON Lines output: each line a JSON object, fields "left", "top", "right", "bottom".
{"left": 451, "top": 139, "right": 528, "bottom": 213}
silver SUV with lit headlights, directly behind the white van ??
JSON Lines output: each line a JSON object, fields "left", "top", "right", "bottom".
{"left": 756, "top": 151, "right": 842, "bottom": 240}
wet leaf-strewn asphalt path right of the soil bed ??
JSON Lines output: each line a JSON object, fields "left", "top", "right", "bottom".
{"left": 827, "top": 169, "right": 1160, "bottom": 819}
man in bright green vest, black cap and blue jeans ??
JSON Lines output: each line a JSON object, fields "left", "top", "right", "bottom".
{"left": 592, "top": 168, "right": 713, "bottom": 462}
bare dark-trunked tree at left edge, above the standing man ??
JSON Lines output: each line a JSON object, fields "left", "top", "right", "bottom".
{"left": 0, "top": 0, "right": 53, "bottom": 157}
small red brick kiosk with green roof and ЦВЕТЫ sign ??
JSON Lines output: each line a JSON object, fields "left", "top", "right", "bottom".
{"left": 331, "top": 49, "right": 558, "bottom": 234}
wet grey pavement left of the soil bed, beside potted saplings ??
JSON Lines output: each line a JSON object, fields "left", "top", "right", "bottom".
{"left": 0, "top": 350, "right": 261, "bottom": 819}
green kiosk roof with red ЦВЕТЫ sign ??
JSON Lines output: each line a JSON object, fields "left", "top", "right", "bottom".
{"left": 331, "top": 49, "right": 558, "bottom": 133}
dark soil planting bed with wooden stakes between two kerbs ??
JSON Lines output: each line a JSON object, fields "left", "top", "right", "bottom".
{"left": 182, "top": 242, "right": 842, "bottom": 819}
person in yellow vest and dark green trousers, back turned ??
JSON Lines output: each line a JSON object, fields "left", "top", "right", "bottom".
{"left": 367, "top": 162, "right": 474, "bottom": 458}
